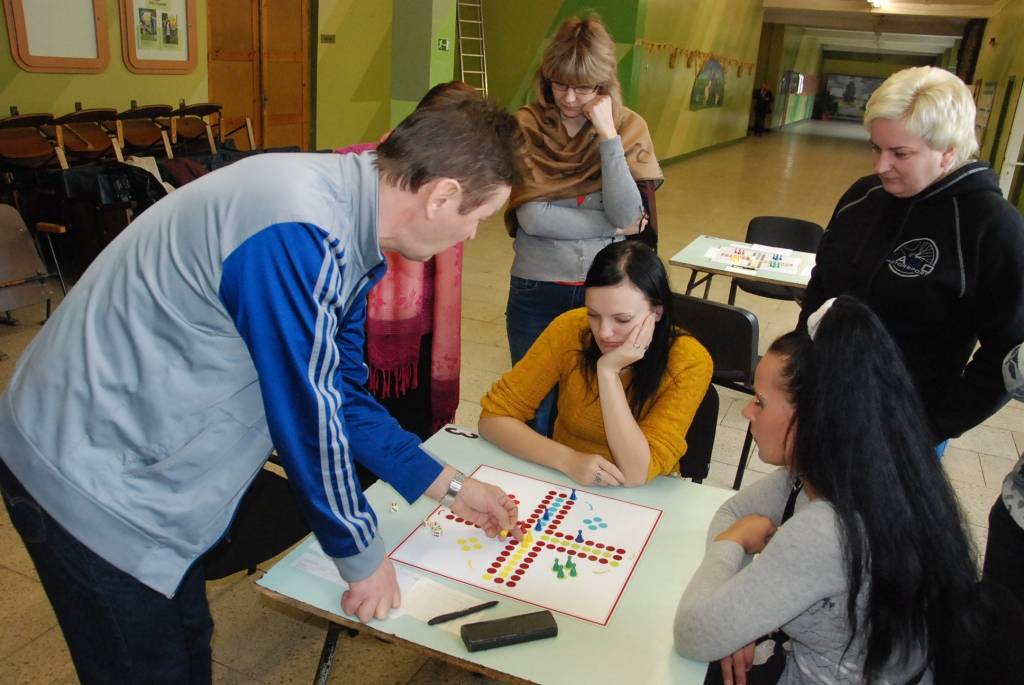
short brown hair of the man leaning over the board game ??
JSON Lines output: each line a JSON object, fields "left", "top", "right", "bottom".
{"left": 377, "top": 96, "right": 523, "bottom": 214}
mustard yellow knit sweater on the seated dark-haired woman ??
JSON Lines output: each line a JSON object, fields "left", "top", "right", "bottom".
{"left": 480, "top": 307, "right": 712, "bottom": 480}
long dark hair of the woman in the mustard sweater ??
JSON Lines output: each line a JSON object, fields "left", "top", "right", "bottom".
{"left": 581, "top": 241, "right": 683, "bottom": 419}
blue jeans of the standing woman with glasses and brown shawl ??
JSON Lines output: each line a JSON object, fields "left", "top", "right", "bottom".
{"left": 505, "top": 276, "right": 584, "bottom": 437}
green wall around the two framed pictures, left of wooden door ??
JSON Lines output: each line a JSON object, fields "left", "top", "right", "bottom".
{"left": 0, "top": 0, "right": 207, "bottom": 116}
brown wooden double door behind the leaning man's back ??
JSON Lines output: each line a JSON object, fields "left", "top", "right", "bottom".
{"left": 207, "top": 0, "right": 310, "bottom": 149}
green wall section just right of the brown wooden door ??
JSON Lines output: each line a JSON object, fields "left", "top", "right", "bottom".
{"left": 315, "top": 0, "right": 391, "bottom": 149}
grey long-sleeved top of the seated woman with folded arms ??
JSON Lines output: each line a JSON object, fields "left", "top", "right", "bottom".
{"left": 674, "top": 469, "right": 932, "bottom": 684}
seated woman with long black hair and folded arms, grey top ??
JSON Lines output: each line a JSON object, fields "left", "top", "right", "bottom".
{"left": 675, "top": 296, "right": 1007, "bottom": 683}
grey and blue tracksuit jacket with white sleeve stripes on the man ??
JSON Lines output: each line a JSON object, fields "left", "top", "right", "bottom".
{"left": 0, "top": 153, "right": 441, "bottom": 596}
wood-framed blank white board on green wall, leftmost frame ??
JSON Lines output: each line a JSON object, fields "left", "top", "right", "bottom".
{"left": 3, "top": 0, "right": 111, "bottom": 74}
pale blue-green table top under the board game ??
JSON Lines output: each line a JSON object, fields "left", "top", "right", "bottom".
{"left": 259, "top": 427, "right": 733, "bottom": 684}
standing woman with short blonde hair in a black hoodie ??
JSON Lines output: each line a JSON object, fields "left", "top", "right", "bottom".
{"left": 800, "top": 67, "right": 1024, "bottom": 446}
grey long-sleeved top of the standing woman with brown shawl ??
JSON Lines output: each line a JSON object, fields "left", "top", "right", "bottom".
{"left": 512, "top": 136, "right": 643, "bottom": 283}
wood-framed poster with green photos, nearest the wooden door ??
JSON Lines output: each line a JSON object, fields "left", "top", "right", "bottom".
{"left": 120, "top": 0, "right": 198, "bottom": 74}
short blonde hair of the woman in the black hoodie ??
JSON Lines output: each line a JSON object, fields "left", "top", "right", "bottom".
{"left": 864, "top": 67, "right": 978, "bottom": 169}
